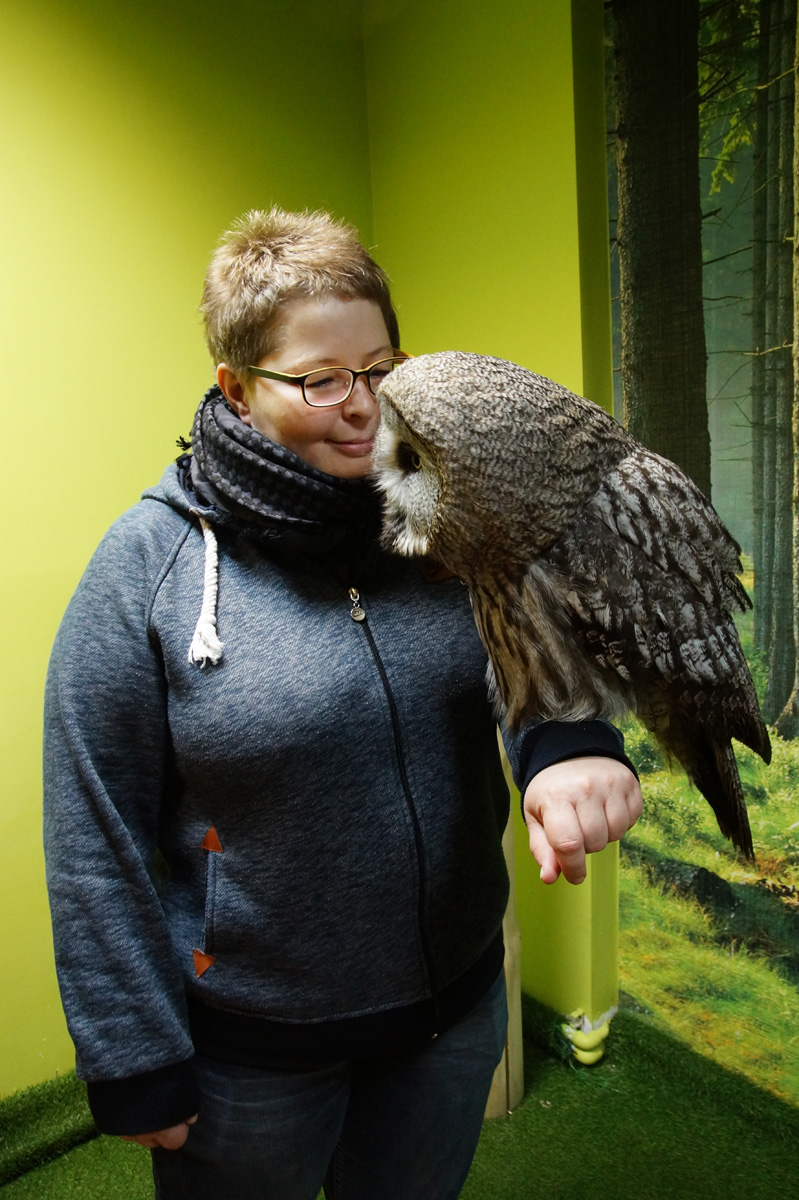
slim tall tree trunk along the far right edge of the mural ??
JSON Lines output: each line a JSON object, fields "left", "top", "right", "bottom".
{"left": 763, "top": 0, "right": 795, "bottom": 721}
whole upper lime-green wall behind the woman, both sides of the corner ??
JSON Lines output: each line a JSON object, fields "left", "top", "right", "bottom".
{"left": 0, "top": 0, "right": 609, "bottom": 1096}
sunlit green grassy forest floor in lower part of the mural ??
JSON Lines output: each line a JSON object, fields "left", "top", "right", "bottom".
{"left": 620, "top": 578, "right": 799, "bottom": 1104}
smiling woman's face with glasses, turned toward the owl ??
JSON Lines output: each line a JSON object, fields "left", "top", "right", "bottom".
{"left": 217, "top": 296, "right": 392, "bottom": 479}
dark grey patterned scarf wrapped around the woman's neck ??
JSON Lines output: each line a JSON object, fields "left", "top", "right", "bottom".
{"left": 185, "top": 384, "right": 382, "bottom": 550}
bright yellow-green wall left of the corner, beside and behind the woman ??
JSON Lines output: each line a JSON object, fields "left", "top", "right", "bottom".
{"left": 0, "top": 0, "right": 371, "bottom": 1094}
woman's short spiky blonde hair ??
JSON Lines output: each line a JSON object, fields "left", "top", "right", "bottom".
{"left": 200, "top": 208, "right": 400, "bottom": 371}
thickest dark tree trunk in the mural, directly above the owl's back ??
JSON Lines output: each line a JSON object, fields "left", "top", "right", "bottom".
{"left": 612, "top": 0, "right": 710, "bottom": 496}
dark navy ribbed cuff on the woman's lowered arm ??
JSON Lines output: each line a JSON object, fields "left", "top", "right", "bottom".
{"left": 86, "top": 1058, "right": 199, "bottom": 1138}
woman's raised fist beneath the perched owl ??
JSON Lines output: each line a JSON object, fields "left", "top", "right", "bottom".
{"left": 523, "top": 757, "right": 642, "bottom": 883}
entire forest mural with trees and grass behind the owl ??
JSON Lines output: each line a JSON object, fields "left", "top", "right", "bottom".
{"left": 606, "top": 0, "right": 799, "bottom": 1103}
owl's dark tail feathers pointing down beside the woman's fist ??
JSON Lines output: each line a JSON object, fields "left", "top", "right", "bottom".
{"left": 653, "top": 720, "right": 748, "bottom": 860}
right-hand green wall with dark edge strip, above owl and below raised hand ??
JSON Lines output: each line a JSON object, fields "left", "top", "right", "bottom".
{"left": 366, "top": 0, "right": 618, "bottom": 1022}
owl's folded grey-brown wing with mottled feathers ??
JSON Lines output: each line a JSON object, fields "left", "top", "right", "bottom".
{"left": 545, "top": 449, "right": 769, "bottom": 756}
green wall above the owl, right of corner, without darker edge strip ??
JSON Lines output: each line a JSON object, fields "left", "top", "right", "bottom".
{"left": 366, "top": 0, "right": 582, "bottom": 390}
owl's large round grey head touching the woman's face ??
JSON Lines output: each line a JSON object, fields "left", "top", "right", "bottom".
{"left": 374, "top": 350, "right": 629, "bottom": 581}
